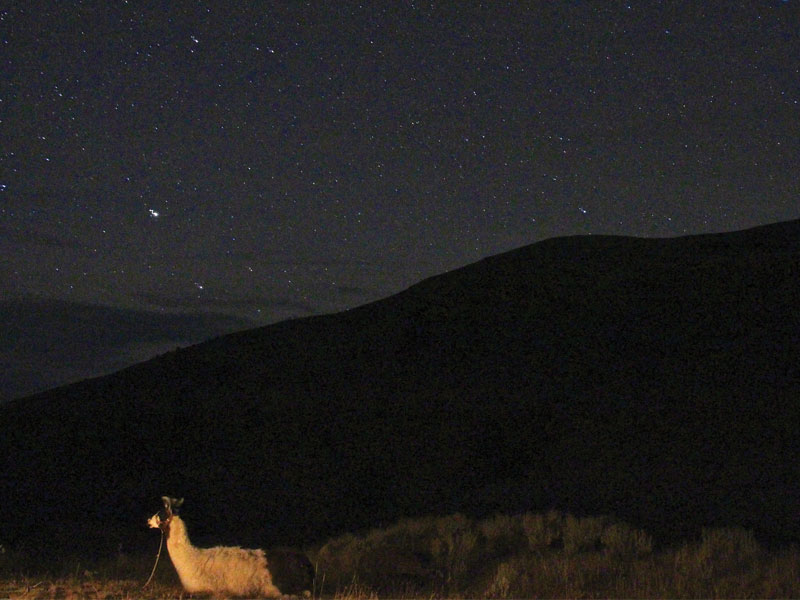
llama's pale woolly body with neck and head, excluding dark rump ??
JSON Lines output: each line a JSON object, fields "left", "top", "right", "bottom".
{"left": 148, "top": 496, "right": 281, "bottom": 598}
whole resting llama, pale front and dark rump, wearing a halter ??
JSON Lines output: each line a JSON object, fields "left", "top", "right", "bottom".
{"left": 147, "top": 496, "right": 313, "bottom": 598}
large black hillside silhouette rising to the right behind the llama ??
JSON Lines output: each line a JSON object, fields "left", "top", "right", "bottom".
{"left": 0, "top": 221, "right": 800, "bottom": 564}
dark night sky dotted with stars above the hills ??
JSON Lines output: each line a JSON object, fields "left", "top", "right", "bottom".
{"left": 0, "top": 0, "right": 800, "bottom": 323}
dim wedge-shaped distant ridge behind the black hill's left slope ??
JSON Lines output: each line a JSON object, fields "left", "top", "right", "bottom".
{"left": 0, "top": 297, "right": 254, "bottom": 402}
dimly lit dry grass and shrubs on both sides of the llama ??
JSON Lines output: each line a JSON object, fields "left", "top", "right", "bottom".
{"left": 0, "top": 511, "right": 800, "bottom": 599}
